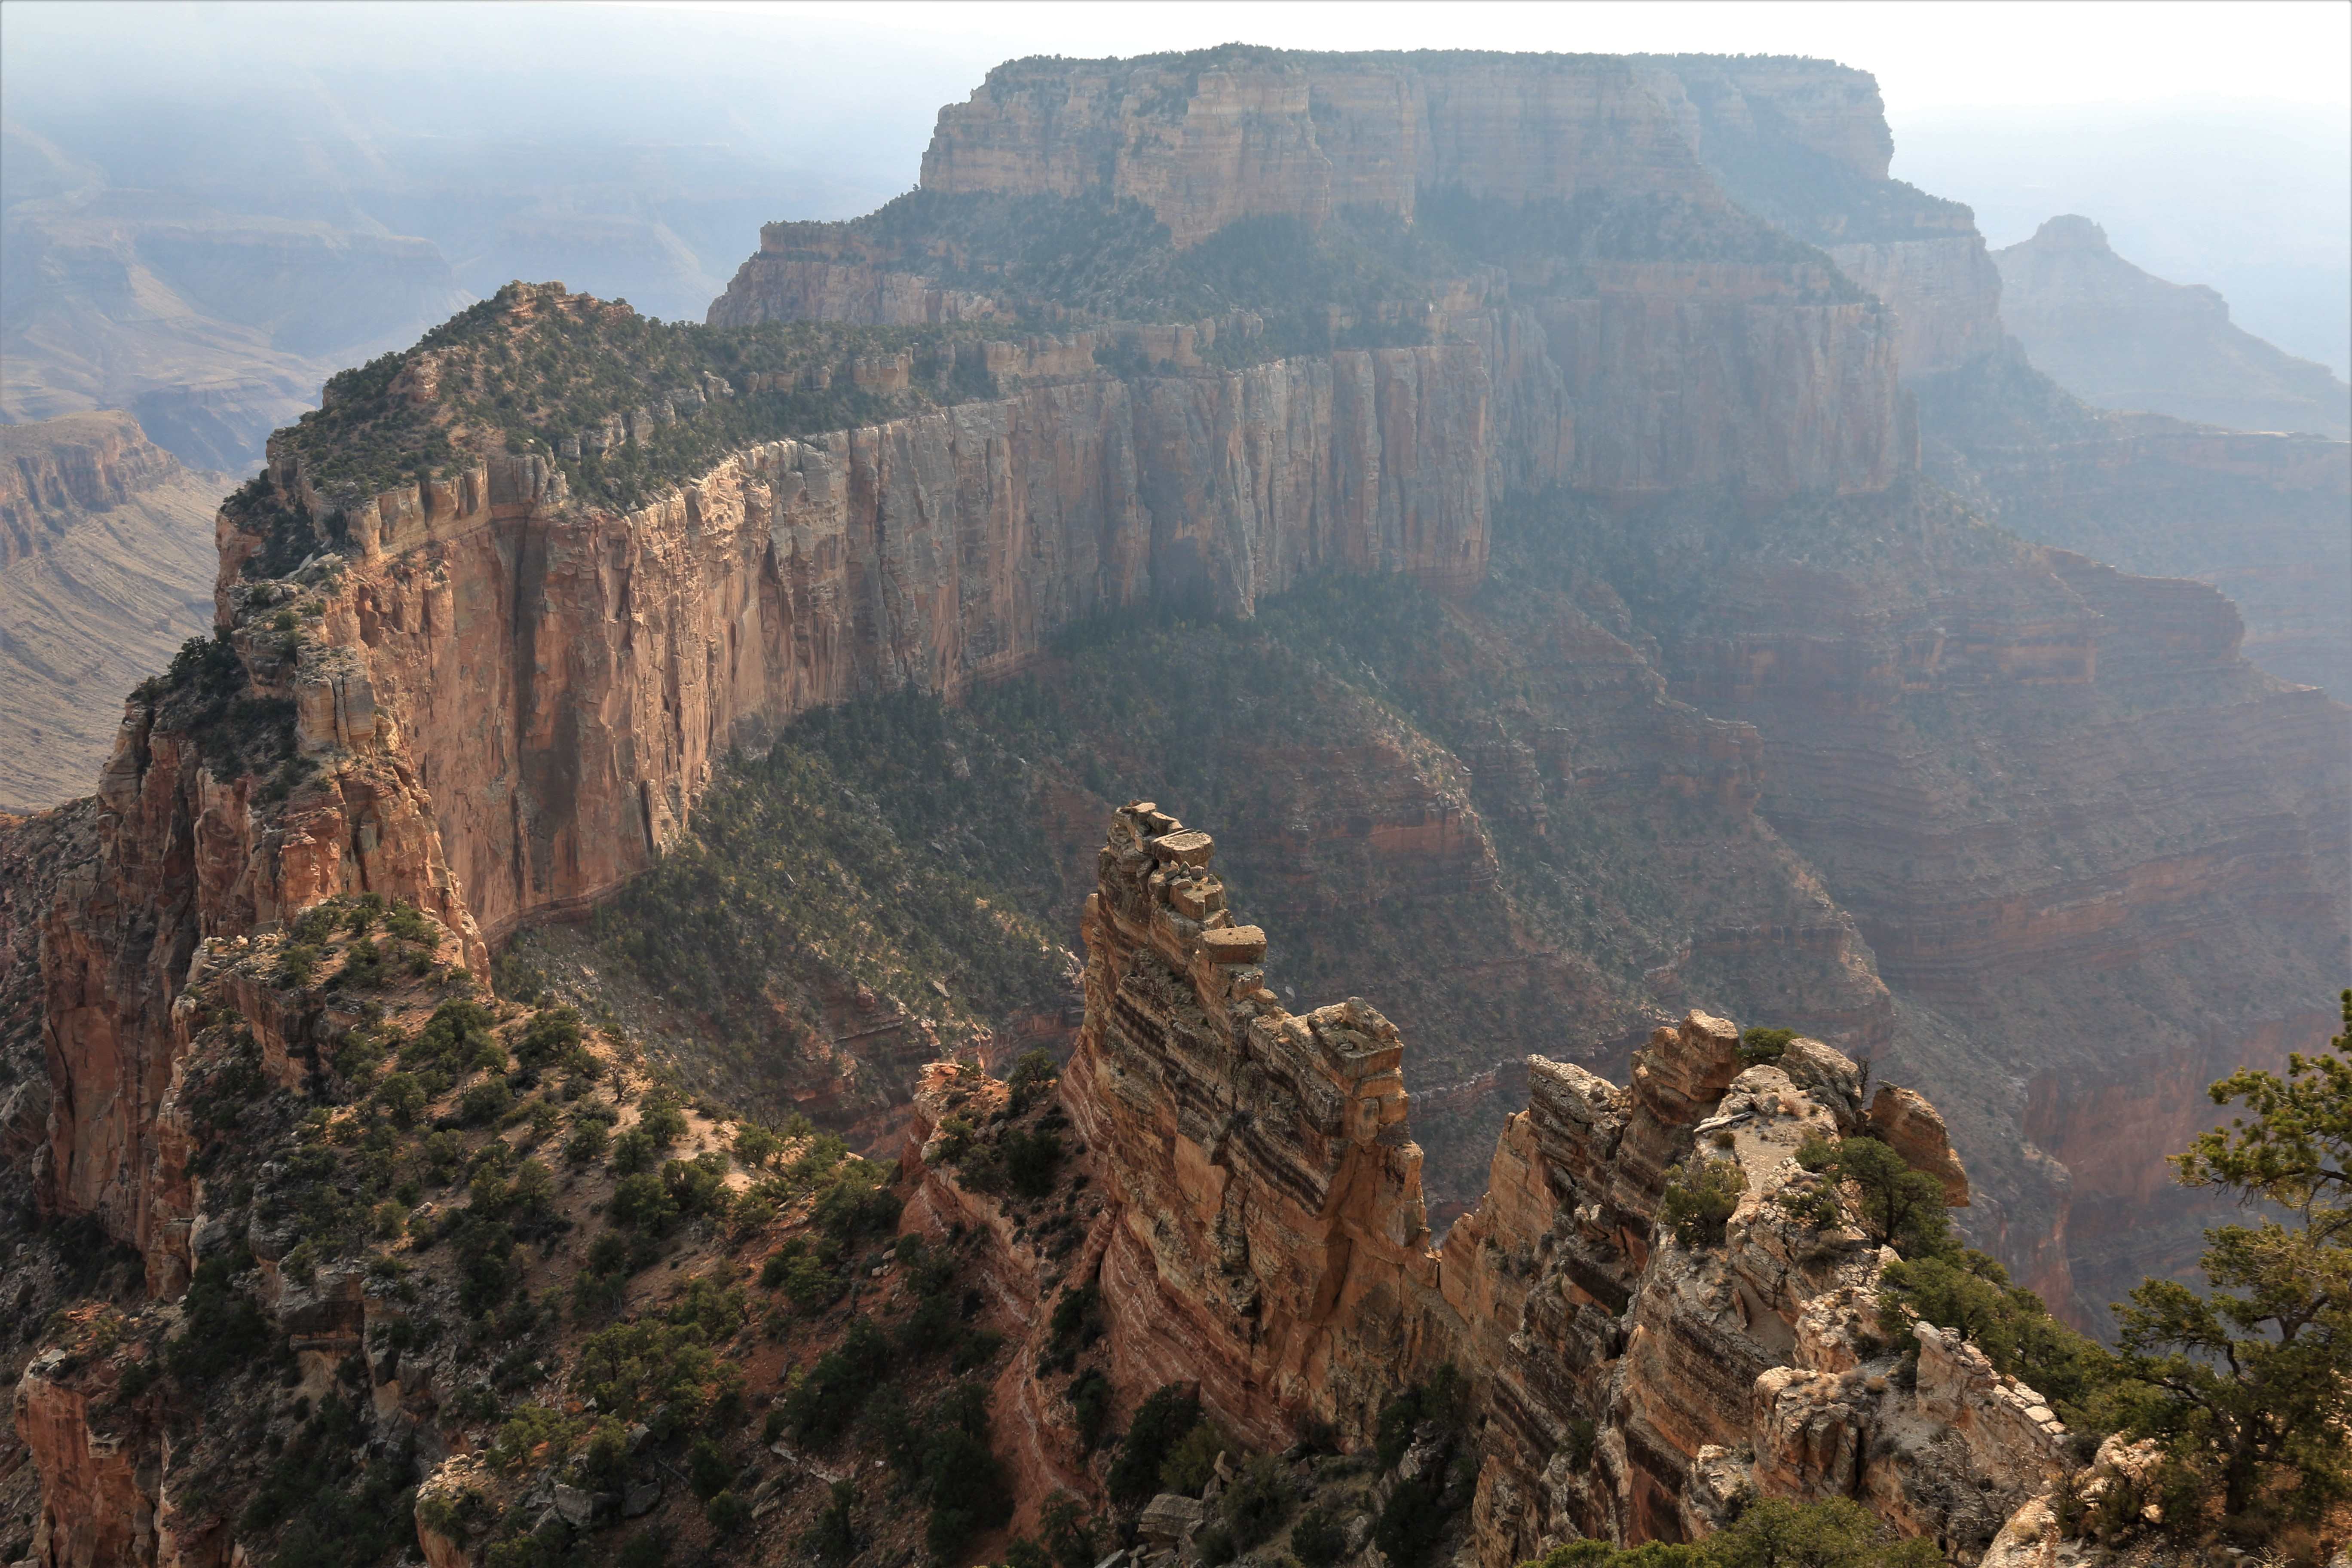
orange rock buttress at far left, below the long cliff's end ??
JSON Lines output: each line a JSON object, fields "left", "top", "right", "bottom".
{"left": 42, "top": 564, "right": 487, "bottom": 1293}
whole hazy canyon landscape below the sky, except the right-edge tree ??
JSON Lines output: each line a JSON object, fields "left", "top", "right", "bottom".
{"left": 0, "top": 18, "right": 2352, "bottom": 1568}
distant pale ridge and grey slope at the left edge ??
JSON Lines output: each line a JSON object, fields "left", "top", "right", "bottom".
{"left": 0, "top": 414, "right": 228, "bottom": 808}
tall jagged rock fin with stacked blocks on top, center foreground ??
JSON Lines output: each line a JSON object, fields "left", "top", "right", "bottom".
{"left": 1063, "top": 804, "right": 1437, "bottom": 1446}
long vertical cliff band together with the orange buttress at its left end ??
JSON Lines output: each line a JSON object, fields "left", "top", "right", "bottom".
{"left": 32, "top": 301, "right": 1491, "bottom": 1283}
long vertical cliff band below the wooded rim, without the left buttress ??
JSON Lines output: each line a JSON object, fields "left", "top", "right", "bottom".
{"left": 262, "top": 334, "right": 1489, "bottom": 938}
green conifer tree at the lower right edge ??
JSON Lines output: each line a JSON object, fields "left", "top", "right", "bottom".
{"left": 2119, "top": 990, "right": 2352, "bottom": 1535}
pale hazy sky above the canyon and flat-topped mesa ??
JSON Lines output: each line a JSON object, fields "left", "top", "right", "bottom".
{"left": 0, "top": 0, "right": 2352, "bottom": 374}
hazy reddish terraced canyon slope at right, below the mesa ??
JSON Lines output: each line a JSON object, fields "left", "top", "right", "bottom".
{"left": 1660, "top": 510, "right": 2352, "bottom": 1323}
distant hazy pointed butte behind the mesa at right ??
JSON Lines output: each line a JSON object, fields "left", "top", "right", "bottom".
{"left": 1992, "top": 214, "right": 2352, "bottom": 440}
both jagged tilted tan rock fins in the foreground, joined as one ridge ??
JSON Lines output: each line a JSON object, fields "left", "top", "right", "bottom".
{"left": 1039, "top": 804, "right": 2065, "bottom": 1566}
